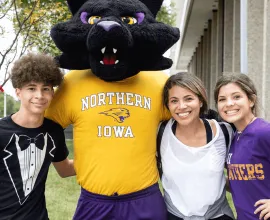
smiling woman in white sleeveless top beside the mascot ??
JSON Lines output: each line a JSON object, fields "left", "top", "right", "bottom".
{"left": 160, "top": 73, "right": 234, "bottom": 220}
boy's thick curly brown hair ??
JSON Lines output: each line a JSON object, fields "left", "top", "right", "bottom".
{"left": 11, "top": 53, "right": 63, "bottom": 88}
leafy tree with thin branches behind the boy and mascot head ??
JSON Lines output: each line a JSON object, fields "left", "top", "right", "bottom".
{"left": 0, "top": 0, "right": 175, "bottom": 84}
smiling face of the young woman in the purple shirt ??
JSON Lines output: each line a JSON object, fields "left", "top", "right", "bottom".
{"left": 217, "top": 83, "right": 254, "bottom": 131}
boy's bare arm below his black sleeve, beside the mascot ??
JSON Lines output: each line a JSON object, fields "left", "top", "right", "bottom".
{"left": 53, "top": 158, "right": 76, "bottom": 178}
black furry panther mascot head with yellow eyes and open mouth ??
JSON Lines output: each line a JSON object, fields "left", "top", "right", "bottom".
{"left": 51, "top": 0, "right": 179, "bottom": 81}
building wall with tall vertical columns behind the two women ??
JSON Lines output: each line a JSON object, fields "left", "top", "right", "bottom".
{"left": 184, "top": 0, "right": 270, "bottom": 120}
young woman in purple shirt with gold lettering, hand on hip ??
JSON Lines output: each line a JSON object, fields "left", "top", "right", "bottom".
{"left": 215, "top": 74, "right": 270, "bottom": 220}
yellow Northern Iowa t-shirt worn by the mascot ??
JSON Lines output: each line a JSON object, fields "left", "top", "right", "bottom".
{"left": 46, "top": 70, "right": 168, "bottom": 195}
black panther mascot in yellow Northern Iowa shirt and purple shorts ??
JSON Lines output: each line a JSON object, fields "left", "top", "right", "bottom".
{"left": 47, "top": 0, "right": 179, "bottom": 220}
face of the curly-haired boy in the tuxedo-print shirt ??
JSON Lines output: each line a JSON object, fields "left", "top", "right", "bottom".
{"left": 16, "top": 82, "right": 54, "bottom": 115}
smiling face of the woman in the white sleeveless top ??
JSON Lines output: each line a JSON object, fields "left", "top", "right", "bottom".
{"left": 168, "top": 86, "right": 202, "bottom": 125}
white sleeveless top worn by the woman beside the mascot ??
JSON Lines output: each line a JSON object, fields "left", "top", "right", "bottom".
{"left": 160, "top": 119, "right": 231, "bottom": 217}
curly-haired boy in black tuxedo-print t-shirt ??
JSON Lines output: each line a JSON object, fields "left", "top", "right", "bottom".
{"left": 0, "top": 53, "right": 75, "bottom": 220}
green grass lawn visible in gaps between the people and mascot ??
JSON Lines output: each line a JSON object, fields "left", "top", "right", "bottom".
{"left": 46, "top": 140, "right": 235, "bottom": 220}
